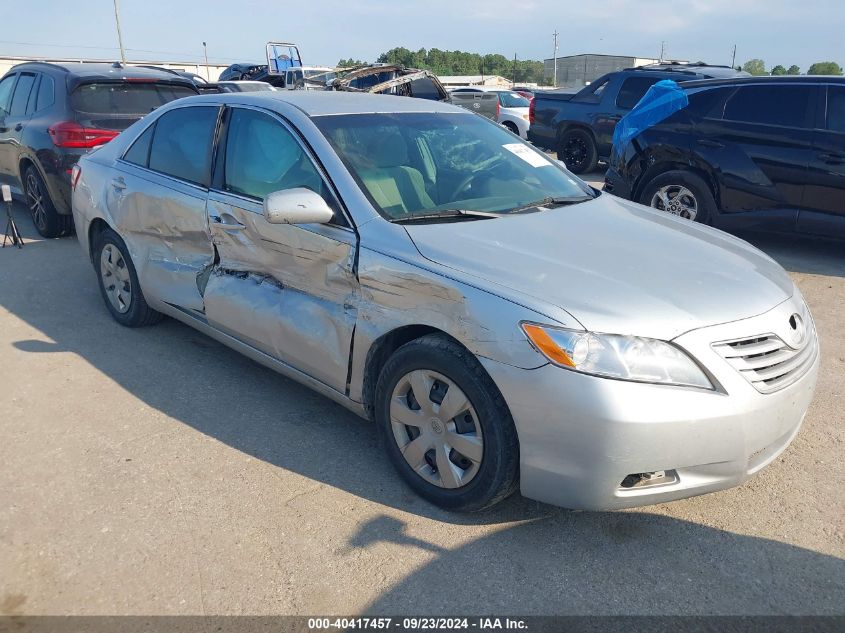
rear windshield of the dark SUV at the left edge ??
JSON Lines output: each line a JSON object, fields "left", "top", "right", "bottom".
{"left": 70, "top": 82, "right": 197, "bottom": 115}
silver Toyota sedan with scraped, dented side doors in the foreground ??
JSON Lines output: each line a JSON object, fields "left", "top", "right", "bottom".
{"left": 72, "top": 91, "right": 819, "bottom": 510}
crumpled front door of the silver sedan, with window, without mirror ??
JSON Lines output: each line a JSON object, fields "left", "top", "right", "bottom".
{"left": 203, "top": 106, "right": 357, "bottom": 392}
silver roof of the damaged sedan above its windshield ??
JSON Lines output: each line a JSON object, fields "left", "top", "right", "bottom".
{"left": 174, "top": 90, "right": 462, "bottom": 117}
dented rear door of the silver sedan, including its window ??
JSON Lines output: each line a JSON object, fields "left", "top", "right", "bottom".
{"left": 112, "top": 105, "right": 220, "bottom": 312}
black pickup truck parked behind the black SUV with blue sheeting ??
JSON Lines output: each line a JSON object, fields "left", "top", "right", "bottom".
{"left": 528, "top": 63, "right": 748, "bottom": 174}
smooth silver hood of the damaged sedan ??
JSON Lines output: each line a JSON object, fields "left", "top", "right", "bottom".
{"left": 405, "top": 194, "right": 794, "bottom": 340}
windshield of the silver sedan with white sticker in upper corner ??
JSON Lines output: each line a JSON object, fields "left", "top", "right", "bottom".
{"left": 313, "top": 112, "right": 595, "bottom": 220}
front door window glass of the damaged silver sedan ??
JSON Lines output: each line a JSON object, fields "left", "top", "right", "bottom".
{"left": 223, "top": 108, "right": 324, "bottom": 200}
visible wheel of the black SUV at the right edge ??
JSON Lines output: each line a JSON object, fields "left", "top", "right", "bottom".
{"left": 640, "top": 170, "right": 716, "bottom": 224}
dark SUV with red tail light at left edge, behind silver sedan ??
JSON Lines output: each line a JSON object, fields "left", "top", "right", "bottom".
{"left": 0, "top": 62, "right": 197, "bottom": 237}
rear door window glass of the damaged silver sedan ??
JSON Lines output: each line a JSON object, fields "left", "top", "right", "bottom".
{"left": 149, "top": 106, "right": 217, "bottom": 187}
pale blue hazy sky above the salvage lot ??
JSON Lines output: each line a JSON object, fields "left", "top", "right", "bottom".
{"left": 0, "top": 0, "right": 845, "bottom": 71}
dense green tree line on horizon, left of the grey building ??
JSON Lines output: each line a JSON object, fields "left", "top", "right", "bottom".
{"left": 338, "top": 46, "right": 543, "bottom": 83}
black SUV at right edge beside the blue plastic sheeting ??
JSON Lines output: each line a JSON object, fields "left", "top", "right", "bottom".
{"left": 605, "top": 77, "right": 845, "bottom": 238}
